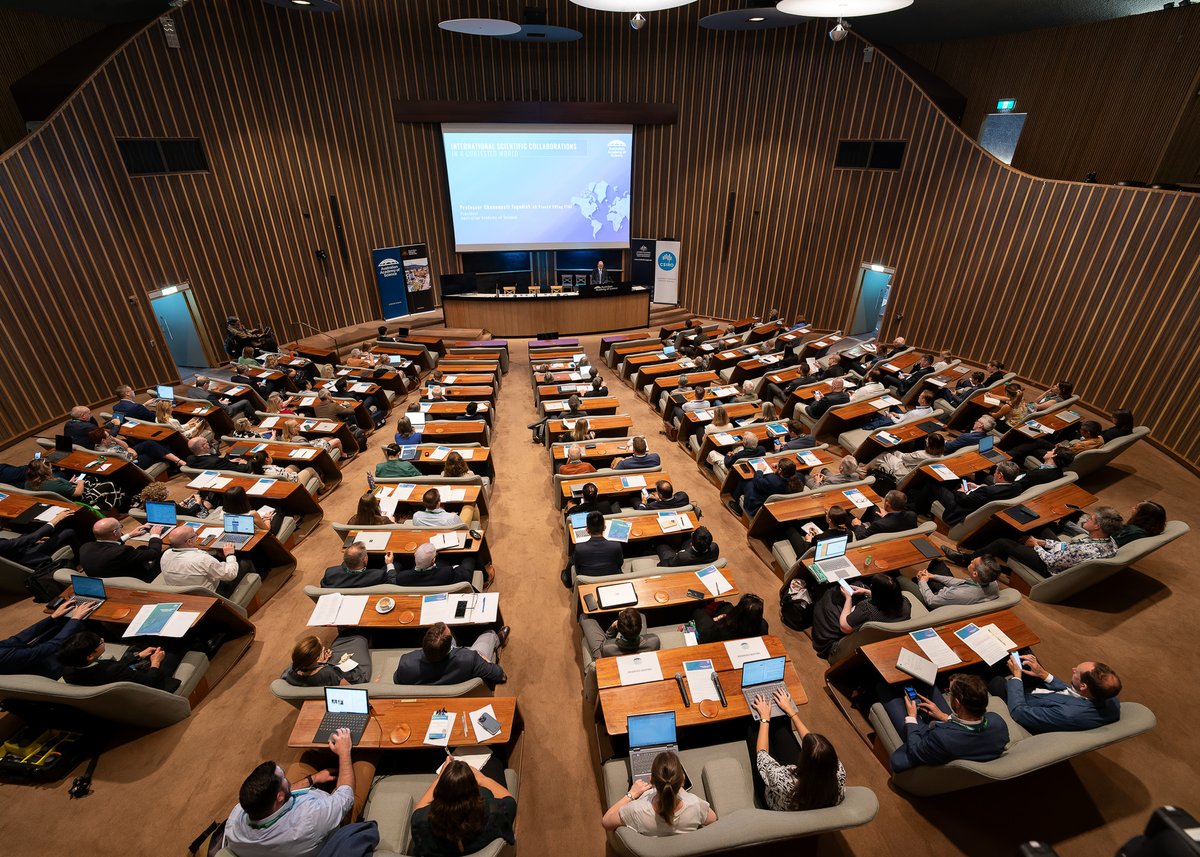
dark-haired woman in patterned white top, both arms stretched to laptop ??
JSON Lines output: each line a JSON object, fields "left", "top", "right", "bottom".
{"left": 748, "top": 688, "right": 846, "bottom": 813}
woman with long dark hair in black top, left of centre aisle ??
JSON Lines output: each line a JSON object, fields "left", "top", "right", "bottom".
{"left": 412, "top": 755, "right": 517, "bottom": 857}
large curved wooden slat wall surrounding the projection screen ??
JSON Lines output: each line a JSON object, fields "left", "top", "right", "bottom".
{"left": 0, "top": 0, "right": 1200, "bottom": 463}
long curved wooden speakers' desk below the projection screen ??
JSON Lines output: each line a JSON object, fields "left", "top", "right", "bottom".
{"left": 442, "top": 288, "right": 650, "bottom": 336}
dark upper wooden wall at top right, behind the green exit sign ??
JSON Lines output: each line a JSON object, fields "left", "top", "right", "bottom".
{"left": 901, "top": 6, "right": 1200, "bottom": 182}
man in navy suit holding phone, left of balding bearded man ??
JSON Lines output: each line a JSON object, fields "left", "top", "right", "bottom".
{"left": 876, "top": 672, "right": 1008, "bottom": 774}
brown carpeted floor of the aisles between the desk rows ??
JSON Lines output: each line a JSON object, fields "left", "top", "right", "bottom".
{"left": 0, "top": 337, "right": 1200, "bottom": 857}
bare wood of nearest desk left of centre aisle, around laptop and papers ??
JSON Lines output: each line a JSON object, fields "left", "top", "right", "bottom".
{"left": 288, "top": 696, "right": 517, "bottom": 750}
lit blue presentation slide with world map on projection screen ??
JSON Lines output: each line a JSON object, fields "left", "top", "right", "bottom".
{"left": 442, "top": 125, "right": 634, "bottom": 253}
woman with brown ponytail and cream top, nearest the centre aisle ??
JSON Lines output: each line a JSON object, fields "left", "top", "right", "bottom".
{"left": 600, "top": 750, "right": 716, "bottom": 837}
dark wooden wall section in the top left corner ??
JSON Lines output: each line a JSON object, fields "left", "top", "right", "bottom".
{"left": 0, "top": 7, "right": 104, "bottom": 150}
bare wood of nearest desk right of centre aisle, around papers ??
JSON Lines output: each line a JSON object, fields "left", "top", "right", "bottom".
{"left": 596, "top": 636, "right": 809, "bottom": 735}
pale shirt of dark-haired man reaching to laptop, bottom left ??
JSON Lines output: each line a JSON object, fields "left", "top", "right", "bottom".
{"left": 226, "top": 786, "right": 354, "bottom": 857}
